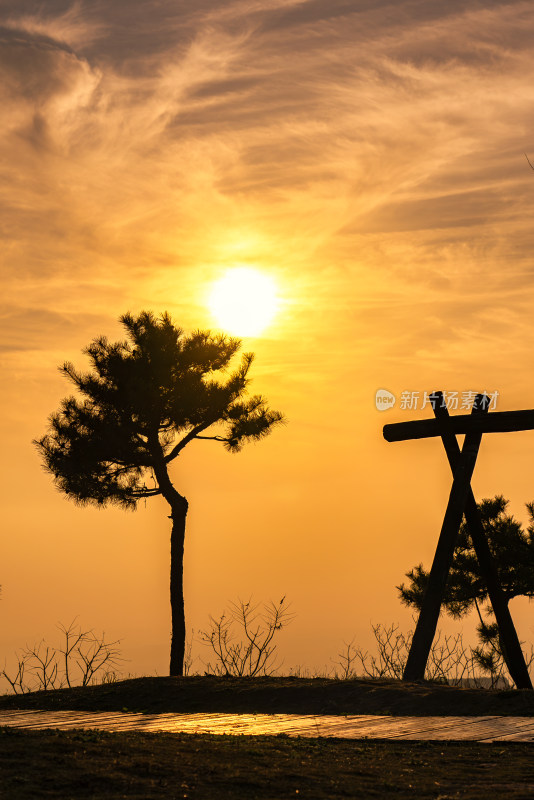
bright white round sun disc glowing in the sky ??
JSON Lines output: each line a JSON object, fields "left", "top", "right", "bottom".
{"left": 208, "top": 267, "right": 279, "bottom": 336}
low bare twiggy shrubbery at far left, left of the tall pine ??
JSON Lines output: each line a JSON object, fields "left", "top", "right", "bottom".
{"left": 0, "top": 620, "right": 123, "bottom": 694}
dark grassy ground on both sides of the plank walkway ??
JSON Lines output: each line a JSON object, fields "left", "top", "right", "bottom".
{"left": 0, "top": 676, "right": 534, "bottom": 800}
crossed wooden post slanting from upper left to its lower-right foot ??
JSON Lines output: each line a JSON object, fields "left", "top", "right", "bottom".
{"left": 432, "top": 392, "right": 532, "bottom": 689}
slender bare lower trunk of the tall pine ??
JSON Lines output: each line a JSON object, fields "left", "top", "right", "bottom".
{"left": 169, "top": 497, "right": 191, "bottom": 675}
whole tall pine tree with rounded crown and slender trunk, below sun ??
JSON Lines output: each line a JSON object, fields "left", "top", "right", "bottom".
{"left": 35, "top": 312, "right": 283, "bottom": 675}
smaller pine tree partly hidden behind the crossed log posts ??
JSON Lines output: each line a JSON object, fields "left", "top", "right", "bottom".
{"left": 397, "top": 495, "right": 534, "bottom": 673}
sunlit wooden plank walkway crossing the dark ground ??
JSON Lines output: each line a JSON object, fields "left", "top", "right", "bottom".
{"left": 0, "top": 710, "right": 534, "bottom": 742}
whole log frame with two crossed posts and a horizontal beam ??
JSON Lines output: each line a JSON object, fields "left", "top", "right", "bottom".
{"left": 383, "top": 392, "right": 534, "bottom": 689}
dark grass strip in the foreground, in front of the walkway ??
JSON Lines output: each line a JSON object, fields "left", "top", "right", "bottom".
{"left": 0, "top": 728, "right": 534, "bottom": 800}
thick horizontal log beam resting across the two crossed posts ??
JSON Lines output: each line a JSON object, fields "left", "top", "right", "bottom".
{"left": 383, "top": 409, "right": 534, "bottom": 442}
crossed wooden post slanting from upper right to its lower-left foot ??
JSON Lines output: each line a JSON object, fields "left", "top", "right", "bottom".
{"left": 403, "top": 395, "right": 487, "bottom": 681}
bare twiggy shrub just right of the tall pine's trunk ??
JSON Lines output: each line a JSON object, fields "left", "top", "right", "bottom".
{"left": 199, "top": 597, "right": 293, "bottom": 677}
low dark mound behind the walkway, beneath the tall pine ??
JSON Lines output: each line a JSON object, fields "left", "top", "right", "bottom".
{"left": 0, "top": 675, "right": 534, "bottom": 716}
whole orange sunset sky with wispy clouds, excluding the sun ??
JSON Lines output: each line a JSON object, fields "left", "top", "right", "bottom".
{"left": 0, "top": 0, "right": 534, "bottom": 675}
